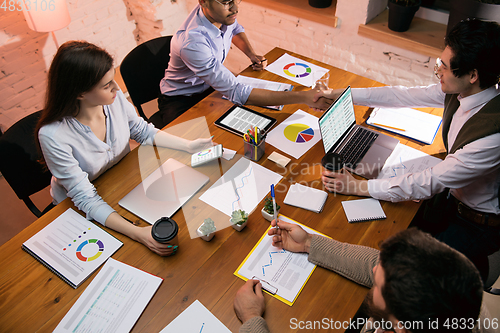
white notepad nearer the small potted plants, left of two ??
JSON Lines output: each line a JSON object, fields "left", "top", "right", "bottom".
{"left": 284, "top": 184, "right": 328, "bottom": 213}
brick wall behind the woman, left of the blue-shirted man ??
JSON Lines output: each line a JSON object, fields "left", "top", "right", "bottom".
{"left": 0, "top": 0, "right": 187, "bottom": 131}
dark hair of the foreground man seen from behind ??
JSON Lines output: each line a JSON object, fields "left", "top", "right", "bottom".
{"left": 380, "top": 228, "right": 483, "bottom": 333}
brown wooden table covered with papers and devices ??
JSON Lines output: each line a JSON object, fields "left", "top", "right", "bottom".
{"left": 0, "top": 48, "right": 443, "bottom": 332}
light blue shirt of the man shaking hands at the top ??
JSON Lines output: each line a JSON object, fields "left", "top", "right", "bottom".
{"left": 160, "top": 5, "right": 252, "bottom": 105}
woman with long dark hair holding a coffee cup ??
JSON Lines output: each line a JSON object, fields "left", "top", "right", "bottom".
{"left": 35, "top": 41, "right": 211, "bottom": 255}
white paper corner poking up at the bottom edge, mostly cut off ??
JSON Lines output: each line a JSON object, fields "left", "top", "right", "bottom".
{"left": 160, "top": 300, "right": 231, "bottom": 333}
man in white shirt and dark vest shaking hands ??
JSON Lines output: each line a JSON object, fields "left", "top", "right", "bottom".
{"left": 322, "top": 19, "right": 500, "bottom": 285}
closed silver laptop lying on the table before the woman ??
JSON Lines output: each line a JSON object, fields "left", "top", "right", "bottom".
{"left": 118, "top": 158, "right": 209, "bottom": 224}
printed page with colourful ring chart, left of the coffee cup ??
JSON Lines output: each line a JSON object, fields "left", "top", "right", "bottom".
{"left": 23, "top": 208, "right": 123, "bottom": 288}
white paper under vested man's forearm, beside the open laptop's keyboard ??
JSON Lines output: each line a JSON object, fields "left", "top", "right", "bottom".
{"left": 377, "top": 143, "right": 441, "bottom": 179}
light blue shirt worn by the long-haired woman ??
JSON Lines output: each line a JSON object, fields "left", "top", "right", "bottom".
{"left": 38, "top": 91, "right": 158, "bottom": 224}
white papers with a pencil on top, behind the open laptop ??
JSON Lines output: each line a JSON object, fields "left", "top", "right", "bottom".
{"left": 366, "top": 108, "right": 442, "bottom": 145}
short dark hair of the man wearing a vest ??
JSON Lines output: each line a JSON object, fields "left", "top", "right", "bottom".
{"left": 445, "top": 19, "right": 500, "bottom": 89}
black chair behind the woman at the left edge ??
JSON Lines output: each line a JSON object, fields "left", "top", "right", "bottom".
{"left": 0, "top": 111, "right": 54, "bottom": 217}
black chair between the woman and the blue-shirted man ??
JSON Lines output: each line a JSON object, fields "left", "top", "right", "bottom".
{"left": 120, "top": 36, "right": 172, "bottom": 128}
